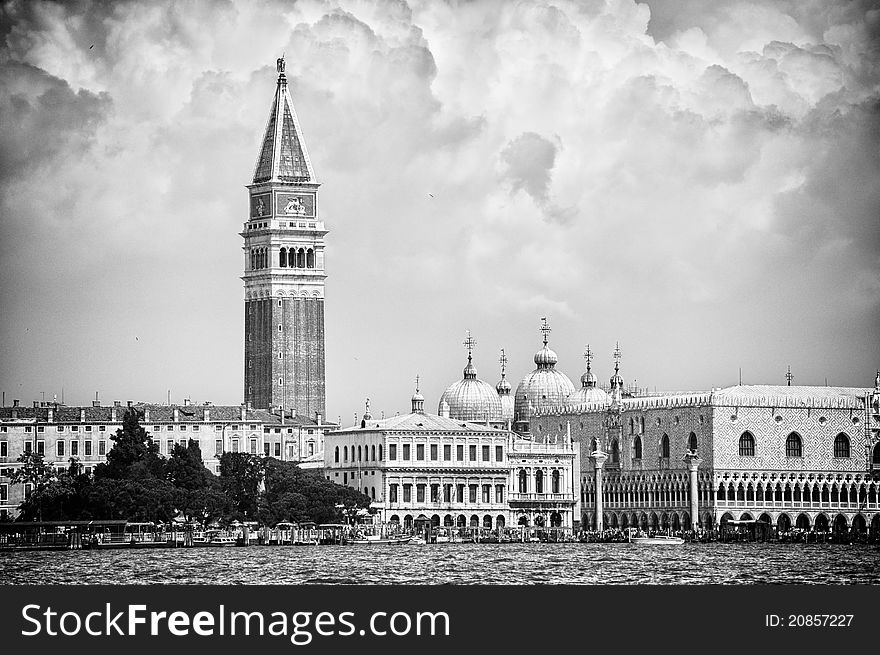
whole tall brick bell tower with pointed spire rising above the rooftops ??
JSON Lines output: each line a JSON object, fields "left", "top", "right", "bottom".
{"left": 241, "top": 59, "right": 327, "bottom": 418}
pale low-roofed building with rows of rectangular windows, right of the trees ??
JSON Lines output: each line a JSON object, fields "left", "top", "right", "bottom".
{"left": 324, "top": 387, "right": 578, "bottom": 529}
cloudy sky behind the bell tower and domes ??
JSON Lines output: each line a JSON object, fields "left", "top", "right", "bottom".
{"left": 0, "top": 0, "right": 880, "bottom": 423}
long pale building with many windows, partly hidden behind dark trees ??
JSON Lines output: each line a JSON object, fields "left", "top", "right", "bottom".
{"left": 0, "top": 401, "right": 337, "bottom": 519}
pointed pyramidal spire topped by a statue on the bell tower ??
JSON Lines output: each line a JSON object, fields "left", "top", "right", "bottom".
{"left": 254, "top": 56, "right": 318, "bottom": 184}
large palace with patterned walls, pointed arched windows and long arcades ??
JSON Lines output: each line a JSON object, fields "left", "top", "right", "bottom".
{"left": 530, "top": 358, "right": 880, "bottom": 534}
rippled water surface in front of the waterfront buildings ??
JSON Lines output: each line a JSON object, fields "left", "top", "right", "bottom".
{"left": 0, "top": 544, "right": 880, "bottom": 585}
